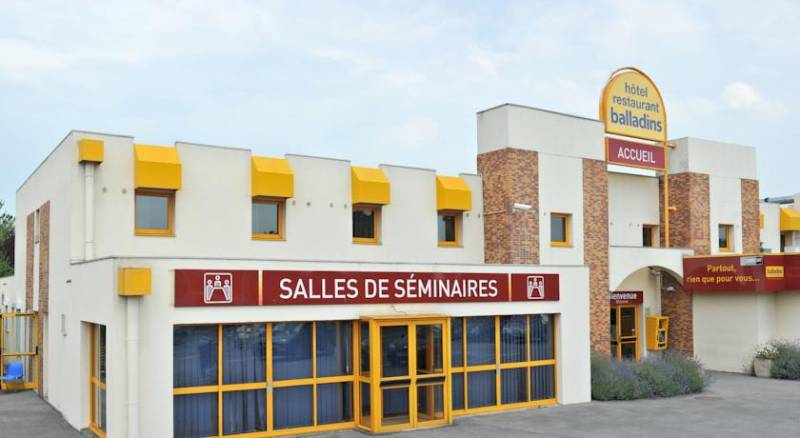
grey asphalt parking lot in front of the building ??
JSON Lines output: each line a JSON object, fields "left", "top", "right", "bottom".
{"left": 0, "top": 373, "right": 800, "bottom": 438}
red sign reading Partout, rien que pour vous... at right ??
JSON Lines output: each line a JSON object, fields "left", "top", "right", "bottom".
{"left": 683, "top": 254, "right": 800, "bottom": 293}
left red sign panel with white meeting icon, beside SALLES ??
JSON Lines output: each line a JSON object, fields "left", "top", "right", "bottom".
{"left": 175, "top": 269, "right": 259, "bottom": 307}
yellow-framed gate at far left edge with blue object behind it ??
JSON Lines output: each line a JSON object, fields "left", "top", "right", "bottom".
{"left": 0, "top": 312, "right": 39, "bottom": 390}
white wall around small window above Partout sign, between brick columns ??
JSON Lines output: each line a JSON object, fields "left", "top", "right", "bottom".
{"left": 708, "top": 175, "right": 742, "bottom": 254}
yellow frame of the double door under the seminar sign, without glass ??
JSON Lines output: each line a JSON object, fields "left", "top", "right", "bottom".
{"left": 357, "top": 315, "right": 452, "bottom": 433}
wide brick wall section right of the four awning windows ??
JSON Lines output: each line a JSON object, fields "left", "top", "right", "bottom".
{"left": 478, "top": 148, "right": 539, "bottom": 265}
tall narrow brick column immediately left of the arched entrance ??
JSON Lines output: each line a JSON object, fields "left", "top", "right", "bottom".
{"left": 583, "top": 159, "right": 611, "bottom": 355}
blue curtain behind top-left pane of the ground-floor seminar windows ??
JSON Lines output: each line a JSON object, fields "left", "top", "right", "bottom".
{"left": 172, "top": 326, "right": 217, "bottom": 388}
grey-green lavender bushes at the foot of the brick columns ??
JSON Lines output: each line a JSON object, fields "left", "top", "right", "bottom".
{"left": 592, "top": 353, "right": 708, "bottom": 400}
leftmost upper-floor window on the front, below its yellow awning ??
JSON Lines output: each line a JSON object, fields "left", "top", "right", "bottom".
{"left": 135, "top": 190, "right": 175, "bottom": 236}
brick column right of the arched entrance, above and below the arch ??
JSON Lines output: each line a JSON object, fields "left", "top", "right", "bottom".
{"left": 659, "top": 172, "right": 711, "bottom": 355}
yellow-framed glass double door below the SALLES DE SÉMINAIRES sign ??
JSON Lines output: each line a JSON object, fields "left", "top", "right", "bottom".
{"left": 361, "top": 318, "right": 451, "bottom": 432}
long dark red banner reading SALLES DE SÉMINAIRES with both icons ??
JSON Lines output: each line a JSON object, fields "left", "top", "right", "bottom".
{"left": 175, "top": 269, "right": 559, "bottom": 307}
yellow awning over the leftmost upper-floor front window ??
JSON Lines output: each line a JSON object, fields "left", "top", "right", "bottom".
{"left": 133, "top": 144, "right": 181, "bottom": 190}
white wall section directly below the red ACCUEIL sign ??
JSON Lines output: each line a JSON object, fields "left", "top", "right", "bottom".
{"left": 608, "top": 172, "right": 660, "bottom": 246}
